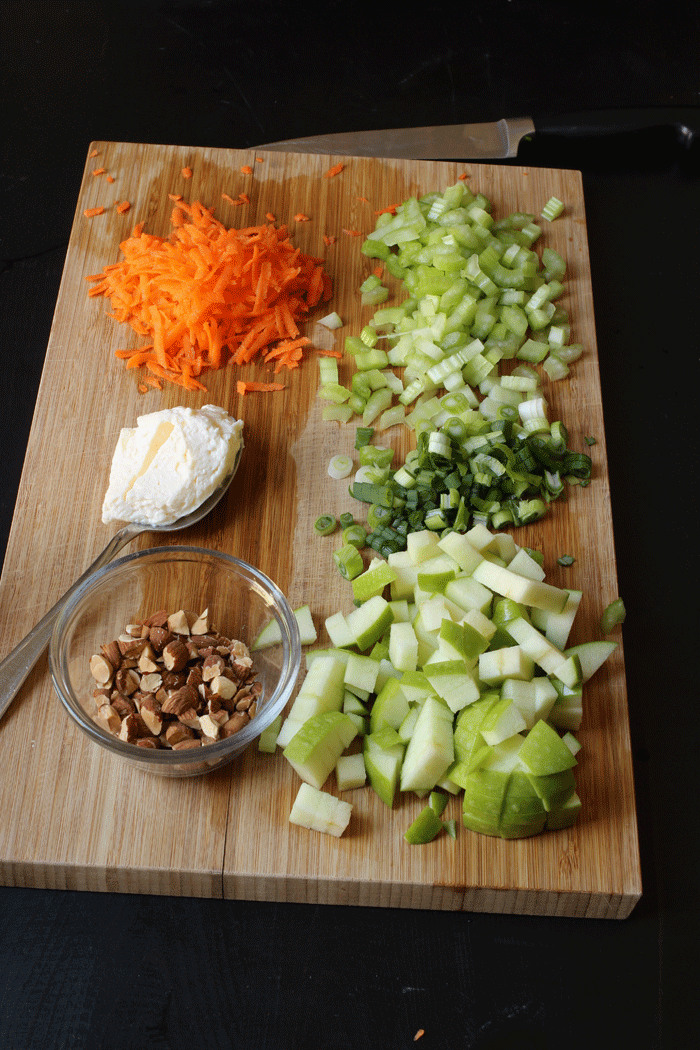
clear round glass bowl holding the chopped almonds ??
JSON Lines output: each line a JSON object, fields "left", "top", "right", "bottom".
{"left": 49, "top": 547, "right": 301, "bottom": 777}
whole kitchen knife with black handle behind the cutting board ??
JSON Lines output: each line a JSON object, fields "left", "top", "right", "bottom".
{"left": 256, "top": 107, "right": 700, "bottom": 161}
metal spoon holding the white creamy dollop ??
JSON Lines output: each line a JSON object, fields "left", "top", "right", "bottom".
{"left": 0, "top": 445, "right": 242, "bottom": 718}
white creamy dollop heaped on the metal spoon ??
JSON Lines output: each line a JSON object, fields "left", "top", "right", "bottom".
{"left": 102, "top": 404, "right": 243, "bottom": 525}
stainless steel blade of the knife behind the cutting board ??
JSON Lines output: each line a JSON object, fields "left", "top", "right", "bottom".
{"left": 256, "top": 117, "right": 535, "bottom": 161}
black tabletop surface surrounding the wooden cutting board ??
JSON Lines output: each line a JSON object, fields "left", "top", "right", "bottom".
{"left": 0, "top": 0, "right": 700, "bottom": 1050}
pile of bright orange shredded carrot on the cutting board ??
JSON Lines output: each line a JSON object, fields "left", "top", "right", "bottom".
{"left": 87, "top": 201, "right": 333, "bottom": 390}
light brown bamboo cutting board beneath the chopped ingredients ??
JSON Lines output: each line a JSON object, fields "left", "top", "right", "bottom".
{"left": 0, "top": 143, "right": 641, "bottom": 918}
